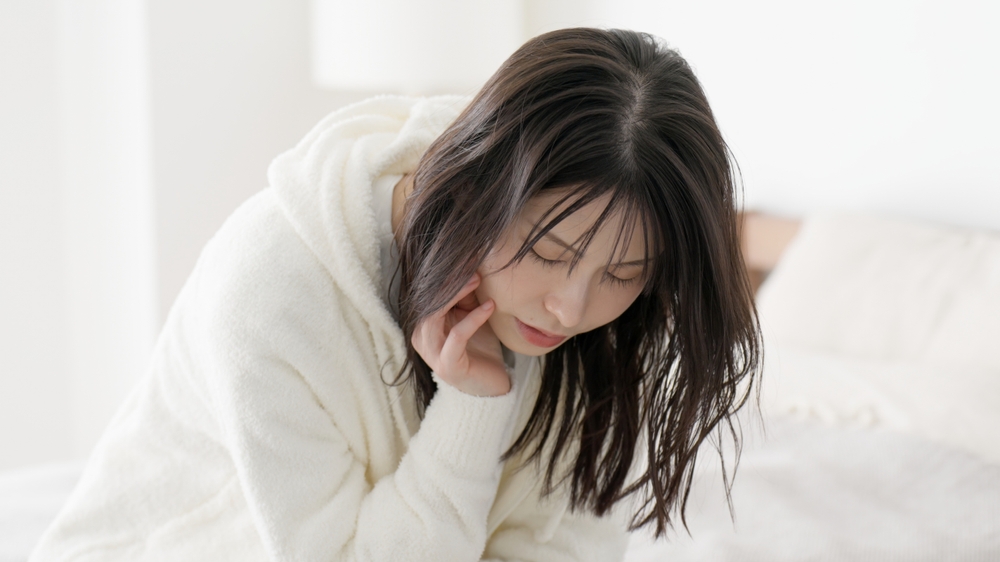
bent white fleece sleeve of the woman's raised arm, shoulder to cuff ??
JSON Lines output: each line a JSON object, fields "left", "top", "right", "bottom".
{"left": 189, "top": 194, "right": 532, "bottom": 562}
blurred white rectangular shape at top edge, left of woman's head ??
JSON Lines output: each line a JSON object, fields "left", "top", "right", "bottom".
{"left": 310, "top": 0, "right": 526, "bottom": 95}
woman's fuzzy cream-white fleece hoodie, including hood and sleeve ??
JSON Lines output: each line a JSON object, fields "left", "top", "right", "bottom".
{"left": 31, "top": 97, "right": 626, "bottom": 562}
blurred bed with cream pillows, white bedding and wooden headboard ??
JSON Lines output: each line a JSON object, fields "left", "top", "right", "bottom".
{"left": 0, "top": 214, "right": 1000, "bottom": 562}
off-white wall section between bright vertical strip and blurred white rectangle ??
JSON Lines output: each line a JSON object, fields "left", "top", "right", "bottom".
{"left": 148, "top": 0, "right": 361, "bottom": 313}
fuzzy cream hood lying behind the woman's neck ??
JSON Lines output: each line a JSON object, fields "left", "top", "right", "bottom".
{"left": 268, "top": 96, "right": 469, "bottom": 352}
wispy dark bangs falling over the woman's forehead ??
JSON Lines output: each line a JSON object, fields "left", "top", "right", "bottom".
{"left": 504, "top": 177, "right": 665, "bottom": 292}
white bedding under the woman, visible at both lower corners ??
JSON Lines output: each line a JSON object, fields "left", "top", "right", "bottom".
{"left": 0, "top": 417, "right": 1000, "bottom": 562}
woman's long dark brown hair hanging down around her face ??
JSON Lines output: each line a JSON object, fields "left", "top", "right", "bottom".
{"left": 399, "top": 28, "right": 760, "bottom": 535}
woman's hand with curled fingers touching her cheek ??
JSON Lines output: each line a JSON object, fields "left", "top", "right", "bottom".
{"left": 412, "top": 273, "right": 510, "bottom": 396}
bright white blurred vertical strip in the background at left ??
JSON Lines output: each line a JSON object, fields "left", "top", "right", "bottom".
{"left": 57, "top": 0, "right": 159, "bottom": 464}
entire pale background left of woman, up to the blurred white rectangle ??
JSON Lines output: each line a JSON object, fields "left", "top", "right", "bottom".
{"left": 0, "top": 0, "right": 358, "bottom": 470}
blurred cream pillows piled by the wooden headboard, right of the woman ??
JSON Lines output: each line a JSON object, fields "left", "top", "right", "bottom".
{"left": 758, "top": 215, "right": 1000, "bottom": 462}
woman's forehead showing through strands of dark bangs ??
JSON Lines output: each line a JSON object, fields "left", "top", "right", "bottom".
{"left": 520, "top": 190, "right": 646, "bottom": 261}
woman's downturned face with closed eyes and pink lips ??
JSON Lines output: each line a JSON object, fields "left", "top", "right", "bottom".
{"left": 476, "top": 189, "right": 645, "bottom": 356}
